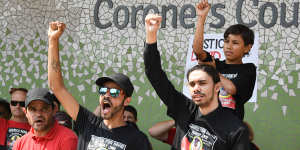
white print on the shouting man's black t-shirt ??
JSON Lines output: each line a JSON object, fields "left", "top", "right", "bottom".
{"left": 87, "top": 135, "right": 126, "bottom": 150}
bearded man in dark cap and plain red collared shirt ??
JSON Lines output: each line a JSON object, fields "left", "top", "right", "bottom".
{"left": 13, "top": 88, "right": 77, "bottom": 150}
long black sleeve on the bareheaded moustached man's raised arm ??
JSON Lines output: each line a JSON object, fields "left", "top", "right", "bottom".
{"left": 144, "top": 43, "right": 197, "bottom": 121}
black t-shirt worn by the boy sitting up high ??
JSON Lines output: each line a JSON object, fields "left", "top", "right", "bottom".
{"left": 206, "top": 52, "right": 256, "bottom": 120}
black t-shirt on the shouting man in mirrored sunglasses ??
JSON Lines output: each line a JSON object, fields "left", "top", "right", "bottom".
{"left": 74, "top": 106, "right": 151, "bottom": 150}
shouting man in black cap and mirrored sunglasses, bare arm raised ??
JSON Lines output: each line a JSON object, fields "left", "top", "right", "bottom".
{"left": 48, "top": 22, "right": 151, "bottom": 150}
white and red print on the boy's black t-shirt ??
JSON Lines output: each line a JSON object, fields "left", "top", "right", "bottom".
{"left": 219, "top": 73, "right": 238, "bottom": 109}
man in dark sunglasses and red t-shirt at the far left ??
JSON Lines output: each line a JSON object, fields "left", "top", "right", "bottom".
{"left": 0, "top": 88, "right": 30, "bottom": 150}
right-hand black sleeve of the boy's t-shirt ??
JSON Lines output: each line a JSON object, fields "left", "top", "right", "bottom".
{"left": 231, "top": 63, "right": 256, "bottom": 104}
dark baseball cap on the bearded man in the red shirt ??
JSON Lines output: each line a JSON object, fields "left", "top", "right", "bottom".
{"left": 25, "top": 88, "right": 53, "bottom": 107}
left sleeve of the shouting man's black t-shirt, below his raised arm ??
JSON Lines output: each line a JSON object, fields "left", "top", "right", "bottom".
{"left": 74, "top": 105, "right": 103, "bottom": 135}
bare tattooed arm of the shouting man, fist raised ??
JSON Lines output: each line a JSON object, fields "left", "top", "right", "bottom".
{"left": 48, "top": 22, "right": 79, "bottom": 120}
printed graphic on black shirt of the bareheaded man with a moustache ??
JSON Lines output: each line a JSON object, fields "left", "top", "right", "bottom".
{"left": 181, "top": 124, "right": 218, "bottom": 150}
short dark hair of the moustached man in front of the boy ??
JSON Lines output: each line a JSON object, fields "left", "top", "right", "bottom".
{"left": 186, "top": 64, "right": 220, "bottom": 84}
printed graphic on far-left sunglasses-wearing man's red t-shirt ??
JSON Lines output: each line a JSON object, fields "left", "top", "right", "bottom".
{"left": 6, "top": 128, "right": 27, "bottom": 150}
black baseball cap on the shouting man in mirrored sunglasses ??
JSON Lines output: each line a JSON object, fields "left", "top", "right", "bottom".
{"left": 96, "top": 73, "right": 134, "bottom": 97}
